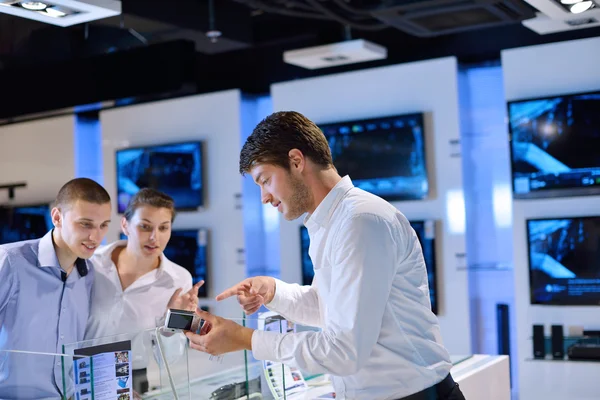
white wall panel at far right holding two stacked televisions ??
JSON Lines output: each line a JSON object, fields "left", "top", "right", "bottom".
{"left": 502, "top": 38, "right": 600, "bottom": 400}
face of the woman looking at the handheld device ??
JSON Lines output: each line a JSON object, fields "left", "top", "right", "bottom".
{"left": 122, "top": 206, "right": 173, "bottom": 258}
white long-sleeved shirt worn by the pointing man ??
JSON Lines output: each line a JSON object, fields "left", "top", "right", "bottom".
{"left": 252, "top": 176, "right": 452, "bottom": 400}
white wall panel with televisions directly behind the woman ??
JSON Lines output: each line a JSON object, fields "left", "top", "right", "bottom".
{"left": 100, "top": 90, "right": 246, "bottom": 318}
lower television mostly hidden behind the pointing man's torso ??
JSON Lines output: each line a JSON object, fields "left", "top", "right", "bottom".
{"left": 300, "top": 220, "right": 438, "bottom": 314}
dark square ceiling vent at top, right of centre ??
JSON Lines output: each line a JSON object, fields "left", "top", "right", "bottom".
{"left": 372, "top": 0, "right": 535, "bottom": 37}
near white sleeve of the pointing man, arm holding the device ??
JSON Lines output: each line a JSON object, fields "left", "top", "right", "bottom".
{"left": 252, "top": 214, "right": 399, "bottom": 376}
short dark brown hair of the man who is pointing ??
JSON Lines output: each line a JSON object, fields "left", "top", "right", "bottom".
{"left": 240, "top": 111, "right": 333, "bottom": 175}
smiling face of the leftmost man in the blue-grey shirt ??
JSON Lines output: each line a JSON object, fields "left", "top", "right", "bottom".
{"left": 52, "top": 200, "right": 111, "bottom": 259}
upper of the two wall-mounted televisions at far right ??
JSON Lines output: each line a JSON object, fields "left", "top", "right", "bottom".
{"left": 508, "top": 92, "right": 600, "bottom": 198}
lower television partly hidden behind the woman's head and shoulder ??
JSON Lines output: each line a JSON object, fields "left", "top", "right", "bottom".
{"left": 120, "top": 229, "right": 210, "bottom": 298}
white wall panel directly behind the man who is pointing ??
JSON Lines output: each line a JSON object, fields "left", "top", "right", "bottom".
{"left": 271, "top": 58, "right": 471, "bottom": 354}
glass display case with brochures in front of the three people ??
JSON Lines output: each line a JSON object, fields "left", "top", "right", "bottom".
{"left": 11, "top": 312, "right": 470, "bottom": 400}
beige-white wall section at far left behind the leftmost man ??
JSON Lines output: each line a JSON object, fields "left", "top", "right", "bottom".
{"left": 0, "top": 115, "right": 75, "bottom": 204}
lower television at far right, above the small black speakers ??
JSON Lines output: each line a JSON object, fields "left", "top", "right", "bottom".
{"left": 527, "top": 217, "right": 600, "bottom": 306}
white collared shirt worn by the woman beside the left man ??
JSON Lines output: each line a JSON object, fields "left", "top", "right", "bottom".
{"left": 85, "top": 240, "right": 192, "bottom": 369}
